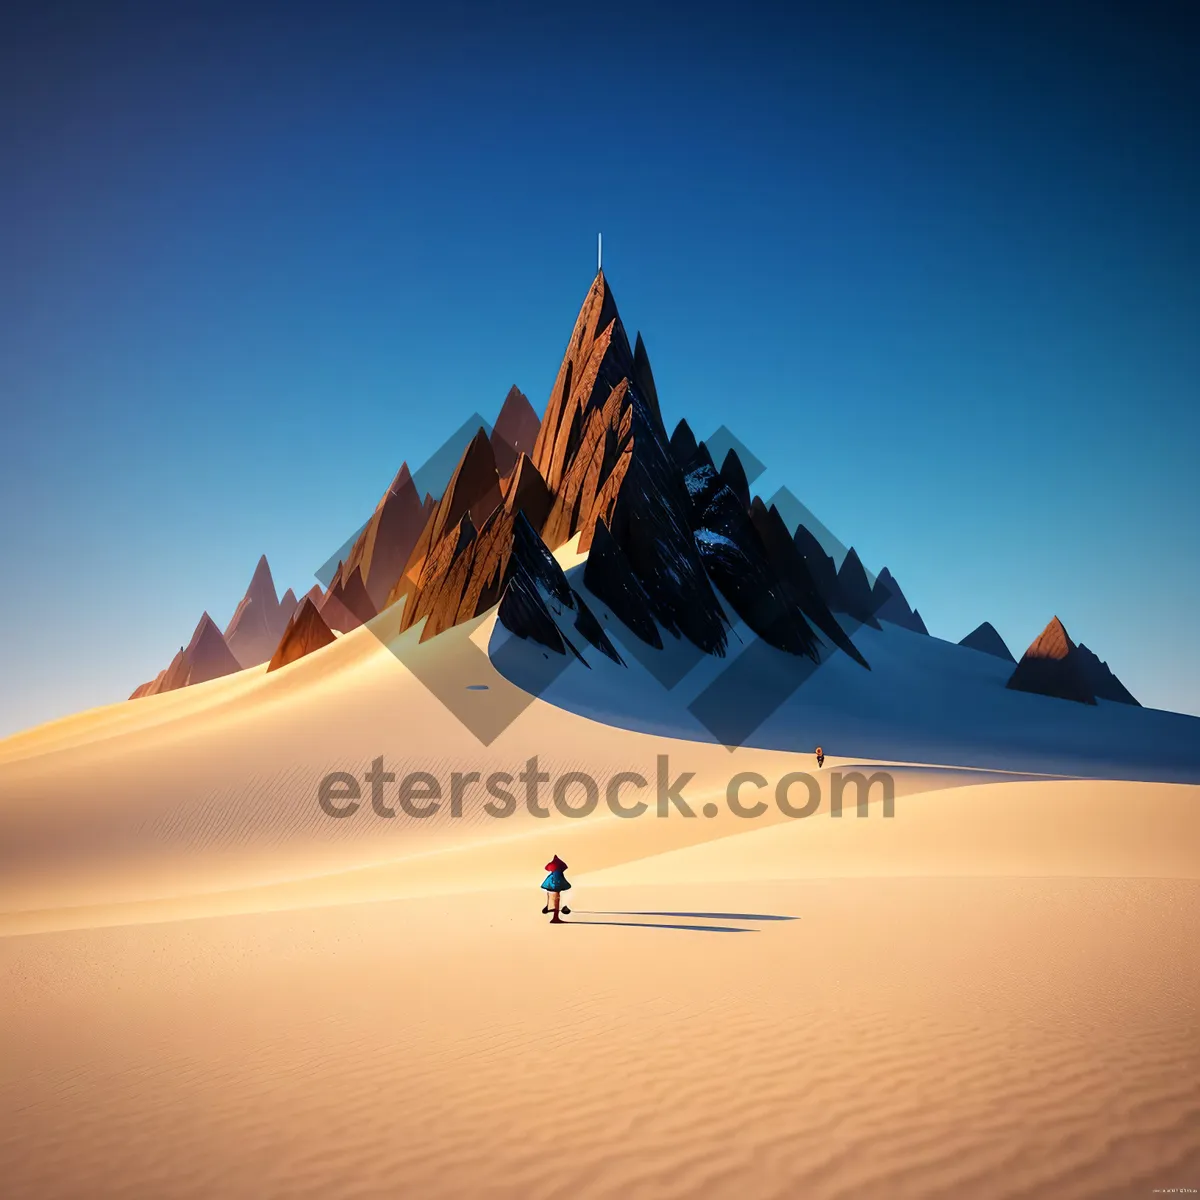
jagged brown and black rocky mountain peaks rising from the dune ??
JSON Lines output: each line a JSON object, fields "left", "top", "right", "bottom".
{"left": 126, "top": 272, "right": 1136, "bottom": 703}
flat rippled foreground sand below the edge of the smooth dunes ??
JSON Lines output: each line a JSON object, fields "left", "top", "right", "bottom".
{"left": 0, "top": 878, "right": 1200, "bottom": 1200}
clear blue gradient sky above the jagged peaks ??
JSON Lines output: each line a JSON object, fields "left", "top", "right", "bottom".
{"left": 0, "top": 2, "right": 1200, "bottom": 734}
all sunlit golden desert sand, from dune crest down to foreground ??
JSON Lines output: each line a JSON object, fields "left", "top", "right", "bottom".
{"left": 0, "top": 600, "right": 1200, "bottom": 1200}
